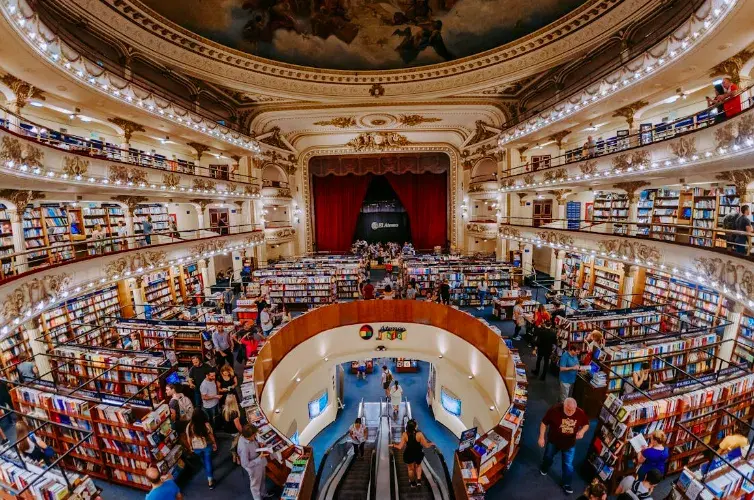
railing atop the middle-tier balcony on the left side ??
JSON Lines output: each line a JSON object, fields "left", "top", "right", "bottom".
{"left": 0, "top": 106, "right": 256, "bottom": 184}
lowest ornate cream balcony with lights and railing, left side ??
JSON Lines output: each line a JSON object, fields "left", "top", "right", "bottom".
{"left": 0, "top": 225, "right": 264, "bottom": 332}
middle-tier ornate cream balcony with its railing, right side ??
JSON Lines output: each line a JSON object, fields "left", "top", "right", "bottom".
{"left": 500, "top": 93, "right": 754, "bottom": 192}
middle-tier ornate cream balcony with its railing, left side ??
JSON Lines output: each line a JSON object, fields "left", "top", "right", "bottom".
{"left": 0, "top": 122, "right": 260, "bottom": 199}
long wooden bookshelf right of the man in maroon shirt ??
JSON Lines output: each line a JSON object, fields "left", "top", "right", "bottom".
{"left": 588, "top": 346, "right": 754, "bottom": 489}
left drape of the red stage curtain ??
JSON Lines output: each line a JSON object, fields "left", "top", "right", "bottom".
{"left": 312, "top": 174, "right": 372, "bottom": 252}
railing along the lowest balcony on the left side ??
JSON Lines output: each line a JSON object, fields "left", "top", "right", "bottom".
{"left": 0, "top": 224, "right": 262, "bottom": 284}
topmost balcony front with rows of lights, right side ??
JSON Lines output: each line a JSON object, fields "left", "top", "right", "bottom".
{"left": 498, "top": 0, "right": 743, "bottom": 146}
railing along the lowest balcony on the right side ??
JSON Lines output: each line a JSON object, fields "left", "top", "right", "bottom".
{"left": 500, "top": 217, "right": 754, "bottom": 261}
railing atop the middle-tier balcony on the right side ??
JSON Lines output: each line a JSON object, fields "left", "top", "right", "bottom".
{"left": 502, "top": 86, "right": 754, "bottom": 178}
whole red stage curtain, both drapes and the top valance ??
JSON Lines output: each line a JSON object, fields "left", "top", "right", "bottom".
{"left": 309, "top": 154, "right": 450, "bottom": 252}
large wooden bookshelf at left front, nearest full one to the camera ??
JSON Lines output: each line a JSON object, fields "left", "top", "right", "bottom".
{"left": 11, "top": 386, "right": 183, "bottom": 491}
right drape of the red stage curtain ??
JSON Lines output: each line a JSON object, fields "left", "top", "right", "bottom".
{"left": 385, "top": 173, "right": 448, "bottom": 250}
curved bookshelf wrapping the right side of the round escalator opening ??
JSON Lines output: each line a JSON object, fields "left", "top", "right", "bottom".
{"left": 452, "top": 349, "right": 528, "bottom": 500}
